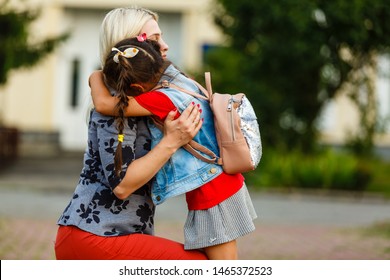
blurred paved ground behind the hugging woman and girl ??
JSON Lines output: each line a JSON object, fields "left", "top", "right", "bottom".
{"left": 0, "top": 154, "right": 390, "bottom": 260}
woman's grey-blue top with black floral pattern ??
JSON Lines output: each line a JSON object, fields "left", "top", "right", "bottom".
{"left": 57, "top": 110, "right": 155, "bottom": 236}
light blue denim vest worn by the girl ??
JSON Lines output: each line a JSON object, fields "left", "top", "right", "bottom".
{"left": 148, "top": 65, "right": 222, "bottom": 205}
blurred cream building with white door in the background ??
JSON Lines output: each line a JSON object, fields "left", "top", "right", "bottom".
{"left": 0, "top": 0, "right": 390, "bottom": 158}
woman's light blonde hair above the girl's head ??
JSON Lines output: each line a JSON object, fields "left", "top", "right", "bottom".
{"left": 99, "top": 6, "right": 158, "bottom": 67}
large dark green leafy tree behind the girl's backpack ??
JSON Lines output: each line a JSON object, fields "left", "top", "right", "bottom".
{"left": 206, "top": 0, "right": 390, "bottom": 152}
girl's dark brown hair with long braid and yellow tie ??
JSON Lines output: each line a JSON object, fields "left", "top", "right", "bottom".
{"left": 103, "top": 38, "right": 164, "bottom": 177}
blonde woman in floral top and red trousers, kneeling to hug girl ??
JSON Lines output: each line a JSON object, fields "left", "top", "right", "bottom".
{"left": 55, "top": 8, "right": 206, "bottom": 259}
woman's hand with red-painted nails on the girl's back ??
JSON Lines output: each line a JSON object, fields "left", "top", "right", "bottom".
{"left": 163, "top": 104, "right": 203, "bottom": 151}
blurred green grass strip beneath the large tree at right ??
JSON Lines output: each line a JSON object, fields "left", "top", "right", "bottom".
{"left": 244, "top": 150, "right": 390, "bottom": 198}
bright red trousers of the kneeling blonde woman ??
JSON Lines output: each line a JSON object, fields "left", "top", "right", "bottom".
{"left": 55, "top": 226, "right": 207, "bottom": 260}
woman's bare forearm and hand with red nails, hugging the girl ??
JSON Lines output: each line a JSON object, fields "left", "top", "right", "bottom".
{"left": 113, "top": 104, "right": 202, "bottom": 199}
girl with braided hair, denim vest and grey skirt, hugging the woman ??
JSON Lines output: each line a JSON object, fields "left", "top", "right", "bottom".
{"left": 90, "top": 35, "right": 256, "bottom": 259}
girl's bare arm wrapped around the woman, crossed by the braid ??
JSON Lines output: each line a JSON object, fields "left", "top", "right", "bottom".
{"left": 89, "top": 71, "right": 152, "bottom": 117}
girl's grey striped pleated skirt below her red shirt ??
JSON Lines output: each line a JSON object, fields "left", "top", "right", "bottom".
{"left": 184, "top": 184, "right": 257, "bottom": 250}
